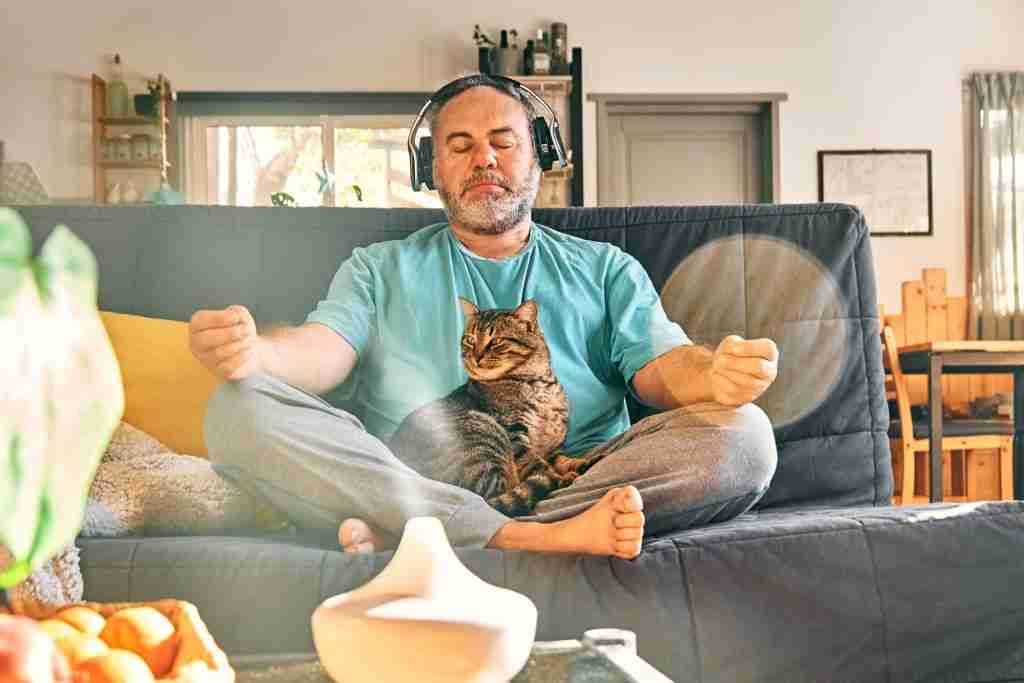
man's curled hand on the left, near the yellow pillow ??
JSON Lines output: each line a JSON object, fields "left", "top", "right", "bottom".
{"left": 188, "top": 305, "right": 263, "bottom": 380}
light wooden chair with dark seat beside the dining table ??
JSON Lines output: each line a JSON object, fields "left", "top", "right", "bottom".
{"left": 882, "top": 326, "right": 1014, "bottom": 505}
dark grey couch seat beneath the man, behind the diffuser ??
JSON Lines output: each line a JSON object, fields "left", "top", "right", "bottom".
{"left": 80, "top": 502, "right": 1024, "bottom": 682}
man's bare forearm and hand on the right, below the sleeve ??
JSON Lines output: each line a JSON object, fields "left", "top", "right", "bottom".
{"left": 633, "top": 335, "right": 778, "bottom": 410}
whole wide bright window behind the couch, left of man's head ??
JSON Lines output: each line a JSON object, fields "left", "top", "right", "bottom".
{"left": 181, "top": 115, "right": 441, "bottom": 208}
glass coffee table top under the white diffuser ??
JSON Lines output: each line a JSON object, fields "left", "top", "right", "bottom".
{"left": 231, "top": 629, "right": 672, "bottom": 683}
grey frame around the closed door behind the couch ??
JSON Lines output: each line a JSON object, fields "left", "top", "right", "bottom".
{"left": 587, "top": 92, "right": 790, "bottom": 206}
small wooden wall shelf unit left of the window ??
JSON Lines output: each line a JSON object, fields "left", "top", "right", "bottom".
{"left": 92, "top": 74, "right": 178, "bottom": 204}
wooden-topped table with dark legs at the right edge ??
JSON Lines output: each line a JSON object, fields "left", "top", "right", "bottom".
{"left": 899, "top": 341, "right": 1024, "bottom": 501}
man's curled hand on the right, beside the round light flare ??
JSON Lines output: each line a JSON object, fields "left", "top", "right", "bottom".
{"left": 709, "top": 335, "right": 778, "bottom": 405}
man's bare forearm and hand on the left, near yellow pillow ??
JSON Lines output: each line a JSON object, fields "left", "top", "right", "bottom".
{"left": 188, "top": 305, "right": 357, "bottom": 394}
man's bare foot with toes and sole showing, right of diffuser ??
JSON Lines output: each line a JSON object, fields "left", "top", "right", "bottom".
{"left": 488, "top": 486, "right": 644, "bottom": 559}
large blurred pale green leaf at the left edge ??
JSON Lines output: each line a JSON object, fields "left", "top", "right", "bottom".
{"left": 0, "top": 208, "right": 124, "bottom": 588}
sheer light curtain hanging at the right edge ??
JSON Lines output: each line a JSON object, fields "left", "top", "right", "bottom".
{"left": 970, "top": 72, "right": 1024, "bottom": 339}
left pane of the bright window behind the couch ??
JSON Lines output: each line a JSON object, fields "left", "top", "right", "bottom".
{"left": 206, "top": 126, "right": 324, "bottom": 206}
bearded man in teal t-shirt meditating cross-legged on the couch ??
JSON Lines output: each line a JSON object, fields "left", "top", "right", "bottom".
{"left": 189, "top": 75, "right": 778, "bottom": 558}
